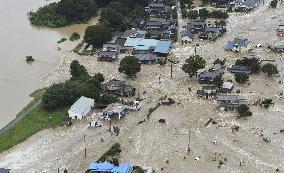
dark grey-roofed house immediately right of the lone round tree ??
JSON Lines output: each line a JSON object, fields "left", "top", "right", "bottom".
{"left": 198, "top": 69, "right": 224, "bottom": 84}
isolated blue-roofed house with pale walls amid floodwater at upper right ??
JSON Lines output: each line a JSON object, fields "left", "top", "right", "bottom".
{"left": 226, "top": 38, "right": 249, "bottom": 52}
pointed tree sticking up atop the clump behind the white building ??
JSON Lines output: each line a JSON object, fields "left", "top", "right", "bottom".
{"left": 70, "top": 60, "right": 89, "bottom": 80}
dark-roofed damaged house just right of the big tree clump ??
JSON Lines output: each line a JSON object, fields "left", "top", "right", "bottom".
{"left": 102, "top": 79, "right": 135, "bottom": 96}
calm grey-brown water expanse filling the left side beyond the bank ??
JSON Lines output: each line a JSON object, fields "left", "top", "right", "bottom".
{"left": 0, "top": 0, "right": 100, "bottom": 128}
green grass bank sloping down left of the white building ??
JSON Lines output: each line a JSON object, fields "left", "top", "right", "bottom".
{"left": 0, "top": 105, "right": 67, "bottom": 152}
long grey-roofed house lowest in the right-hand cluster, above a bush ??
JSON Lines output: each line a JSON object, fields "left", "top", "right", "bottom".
{"left": 217, "top": 95, "right": 248, "bottom": 109}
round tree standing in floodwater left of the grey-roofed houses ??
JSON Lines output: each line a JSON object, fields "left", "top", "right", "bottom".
{"left": 182, "top": 55, "right": 206, "bottom": 77}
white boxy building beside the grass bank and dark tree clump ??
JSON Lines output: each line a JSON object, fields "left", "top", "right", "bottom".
{"left": 68, "top": 96, "right": 95, "bottom": 120}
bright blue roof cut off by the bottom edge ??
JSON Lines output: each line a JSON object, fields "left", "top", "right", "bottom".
{"left": 86, "top": 162, "right": 133, "bottom": 173}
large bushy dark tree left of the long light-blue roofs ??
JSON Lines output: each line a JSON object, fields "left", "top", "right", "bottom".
{"left": 84, "top": 24, "right": 112, "bottom": 48}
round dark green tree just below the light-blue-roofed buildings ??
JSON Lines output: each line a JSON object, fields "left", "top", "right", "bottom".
{"left": 118, "top": 56, "right": 141, "bottom": 76}
